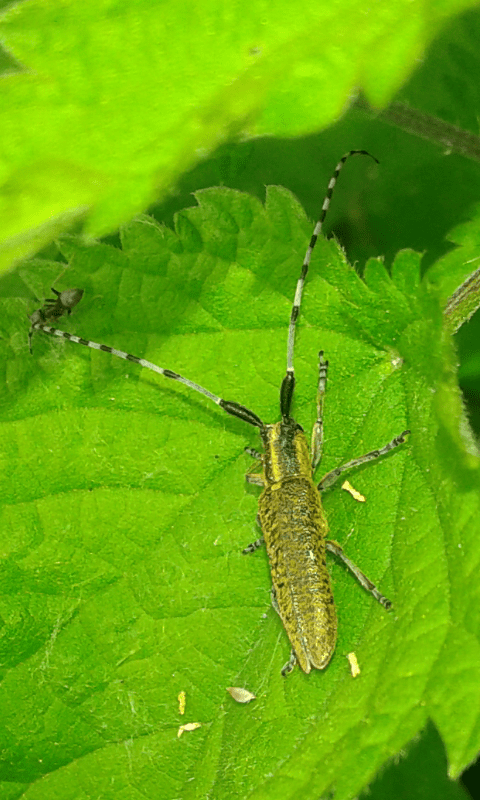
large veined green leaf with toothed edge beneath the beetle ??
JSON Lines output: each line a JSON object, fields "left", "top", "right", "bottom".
{"left": 0, "top": 188, "right": 480, "bottom": 800}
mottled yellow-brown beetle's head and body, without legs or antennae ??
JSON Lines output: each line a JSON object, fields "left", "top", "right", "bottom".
{"left": 258, "top": 420, "right": 337, "bottom": 672}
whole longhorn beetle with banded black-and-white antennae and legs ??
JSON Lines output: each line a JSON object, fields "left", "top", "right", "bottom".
{"left": 30, "top": 150, "right": 410, "bottom": 675}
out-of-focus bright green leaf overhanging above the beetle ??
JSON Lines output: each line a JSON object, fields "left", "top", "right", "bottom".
{"left": 0, "top": 0, "right": 473, "bottom": 265}
